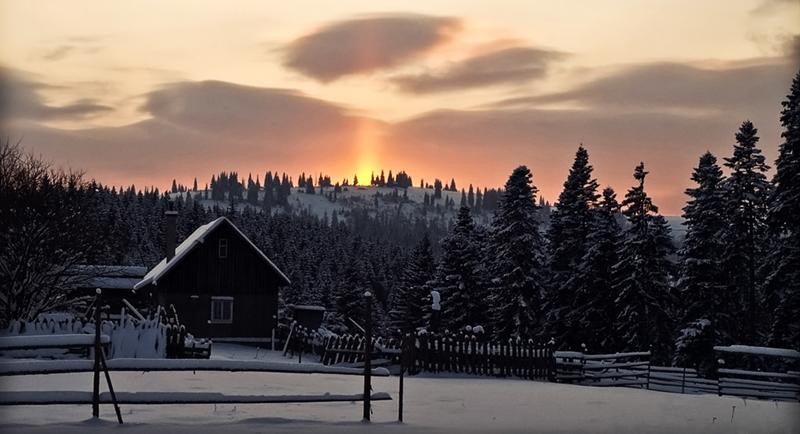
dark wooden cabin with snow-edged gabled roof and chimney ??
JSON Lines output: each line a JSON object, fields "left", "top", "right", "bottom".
{"left": 134, "top": 211, "right": 289, "bottom": 342}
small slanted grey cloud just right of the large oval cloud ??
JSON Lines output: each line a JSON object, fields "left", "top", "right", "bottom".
{"left": 392, "top": 47, "right": 566, "bottom": 93}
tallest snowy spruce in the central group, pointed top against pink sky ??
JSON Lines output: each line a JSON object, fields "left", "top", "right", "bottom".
{"left": 540, "top": 145, "right": 599, "bottom": 348}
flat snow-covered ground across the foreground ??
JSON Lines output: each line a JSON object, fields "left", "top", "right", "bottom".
{"left": 0, "top": 345, "right": 800, "bottom": 433}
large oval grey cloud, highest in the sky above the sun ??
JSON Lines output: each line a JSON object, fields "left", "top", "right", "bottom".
{"left": 283, "top": 14, "right": 461, "bottom": 82}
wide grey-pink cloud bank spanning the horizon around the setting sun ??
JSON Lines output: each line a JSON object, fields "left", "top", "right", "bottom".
{"left": 6, "top": 54, "right": 796, "bottom": 214}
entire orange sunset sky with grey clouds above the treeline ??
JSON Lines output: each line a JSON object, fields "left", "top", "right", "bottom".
{"left": 0, "top": 0, "right": 800, "bottom": 215}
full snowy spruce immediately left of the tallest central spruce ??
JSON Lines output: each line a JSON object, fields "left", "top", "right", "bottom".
{"left": 487, "top": 166, "right": 544, "bottom": 339}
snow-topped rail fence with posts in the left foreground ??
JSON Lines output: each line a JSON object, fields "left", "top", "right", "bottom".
{"left": 0, "top": 289, "right": 392, "bottom": 424}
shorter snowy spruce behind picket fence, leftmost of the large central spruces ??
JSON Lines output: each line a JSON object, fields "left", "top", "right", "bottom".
{"left": 431, "top": 207, "right": 487, "bottom": 331}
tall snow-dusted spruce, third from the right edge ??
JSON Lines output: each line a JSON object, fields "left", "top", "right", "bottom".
{"left": 676, "top": 152, "right": 732, "bottom": 343}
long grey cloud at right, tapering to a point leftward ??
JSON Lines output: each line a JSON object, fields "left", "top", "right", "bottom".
{"left": 493, "top": 59, "right": 796, "bottom": 114}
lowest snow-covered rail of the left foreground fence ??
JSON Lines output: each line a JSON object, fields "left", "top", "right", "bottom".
{"left": 0, "top": 391, "right": 392, "bottom": 405}
